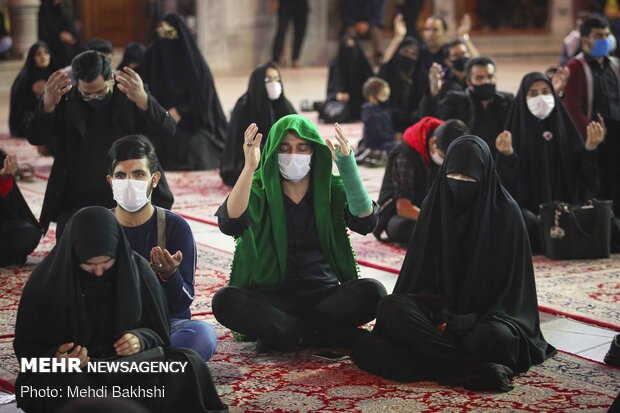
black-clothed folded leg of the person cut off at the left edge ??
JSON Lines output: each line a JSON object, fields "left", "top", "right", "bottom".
{"left": 0, "top": 219, "right": 42, "bottom": 266}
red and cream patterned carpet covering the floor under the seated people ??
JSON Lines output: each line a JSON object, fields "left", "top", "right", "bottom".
{"left": 0, "top": 132, "right": 620, "bottom": 412}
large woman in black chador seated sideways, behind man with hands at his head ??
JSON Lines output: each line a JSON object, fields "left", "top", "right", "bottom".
{"left": 140, "top": 14, "right": 228, "bottom": 170}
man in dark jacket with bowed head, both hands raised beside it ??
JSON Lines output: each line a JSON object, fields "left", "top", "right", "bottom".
{"left": 27, "top": 50, "right": 175, "bottom": 239}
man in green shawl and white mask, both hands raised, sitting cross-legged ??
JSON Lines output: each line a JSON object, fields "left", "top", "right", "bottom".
{"left": 213, "top": 115, "right": 386, "bottom": 352}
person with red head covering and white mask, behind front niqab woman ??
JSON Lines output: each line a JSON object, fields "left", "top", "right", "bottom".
{"left": 373, "top": 116, "right": 469, "bottom": 244}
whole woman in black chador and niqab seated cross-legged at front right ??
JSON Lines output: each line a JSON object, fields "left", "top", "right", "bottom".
{"left": 353, "top": 136, "right": 555, "bottom": 391}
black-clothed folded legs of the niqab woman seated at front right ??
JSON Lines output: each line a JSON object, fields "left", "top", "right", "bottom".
{"left": 353, "top": 294, "right": 519, "bottom": 391}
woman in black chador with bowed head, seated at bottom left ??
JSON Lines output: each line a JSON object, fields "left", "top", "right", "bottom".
{"left": 13, "top": 207, "right": 227, "bottom": 413}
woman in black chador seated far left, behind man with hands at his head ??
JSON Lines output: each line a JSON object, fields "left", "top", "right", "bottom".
{"left": 9, "top": 41, "right": 56, "bottom": 137}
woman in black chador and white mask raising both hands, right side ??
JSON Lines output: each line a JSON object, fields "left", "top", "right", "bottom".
{"left": 497, "top": 72, "right": 598, "bottom": 252}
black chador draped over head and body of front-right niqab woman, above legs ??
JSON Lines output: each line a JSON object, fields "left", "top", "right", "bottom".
{"left": 394, "top": 136, "right": 555, "bottom": 373}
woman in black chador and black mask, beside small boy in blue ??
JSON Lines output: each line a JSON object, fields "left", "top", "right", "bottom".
{"left": 378, "top": 37, "right": 428, "bottom": 132}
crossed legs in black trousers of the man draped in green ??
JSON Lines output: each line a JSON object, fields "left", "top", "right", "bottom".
{"left": 212, "top": 279, "right": 386, "bottom": 351}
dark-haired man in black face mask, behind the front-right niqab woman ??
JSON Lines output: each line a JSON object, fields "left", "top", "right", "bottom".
{"left": 437, "top": 56, "right": 514, "bottom": 155}
